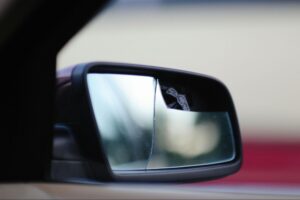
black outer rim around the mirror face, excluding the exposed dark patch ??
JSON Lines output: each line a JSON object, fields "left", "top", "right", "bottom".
{"left": 72, "top": 62, "right": 242, "bottom": 182}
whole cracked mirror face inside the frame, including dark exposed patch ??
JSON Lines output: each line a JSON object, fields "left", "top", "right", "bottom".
{"left": 87, "top": 73, "right": 235, "bottom": 172}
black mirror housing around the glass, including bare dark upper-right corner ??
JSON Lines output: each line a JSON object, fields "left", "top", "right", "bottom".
{"left": 67, "top": 62, "right": 242, "bottom": 182}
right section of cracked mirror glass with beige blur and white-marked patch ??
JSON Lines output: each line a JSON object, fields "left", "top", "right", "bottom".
{"left": 147, "top": 80, "right": 234, "bottom": 169}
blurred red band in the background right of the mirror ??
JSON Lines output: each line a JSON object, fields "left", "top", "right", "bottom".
{"left": 200, "top": 139, "right": 300, "bottom": 186}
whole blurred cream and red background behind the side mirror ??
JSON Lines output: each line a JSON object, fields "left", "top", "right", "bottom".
{"left": 57, "top": 0, "right": 300, "bottom": 187}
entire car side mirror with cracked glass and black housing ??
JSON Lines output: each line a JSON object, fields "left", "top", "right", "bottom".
{"left": 65, "top": 63, "right": 242, "bottom": 182}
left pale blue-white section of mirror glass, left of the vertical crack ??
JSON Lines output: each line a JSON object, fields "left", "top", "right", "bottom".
{"left": 87, "top": 74, "right": 156, "bottom": 170}
